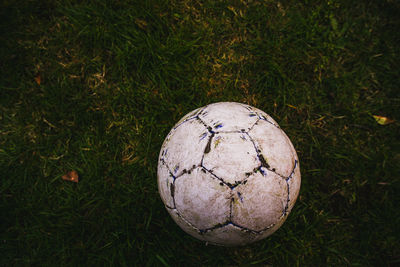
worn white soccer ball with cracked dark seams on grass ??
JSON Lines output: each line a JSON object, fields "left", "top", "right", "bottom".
{"left": 157, "top": 102, "right": 301, "bottom": 246}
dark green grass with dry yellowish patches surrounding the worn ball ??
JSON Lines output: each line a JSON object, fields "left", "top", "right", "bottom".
{"left": 0, "top": 0, "right": 400, "bottom": 266}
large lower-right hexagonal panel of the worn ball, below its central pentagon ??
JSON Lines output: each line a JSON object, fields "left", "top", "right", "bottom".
{"left": 232, "top": 170, "right": 287, "bottom": 231}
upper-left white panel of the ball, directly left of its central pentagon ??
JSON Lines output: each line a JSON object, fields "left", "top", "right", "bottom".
{"left": 160, "top": 119, "right": 210, "bottom": 176}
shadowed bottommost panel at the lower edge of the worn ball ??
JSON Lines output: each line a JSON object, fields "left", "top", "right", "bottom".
{"left": 203, "top": 223, "right": 257, "bottom": 246}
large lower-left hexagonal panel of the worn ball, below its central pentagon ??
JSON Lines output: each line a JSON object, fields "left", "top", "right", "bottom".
{"left": 174, "top": 168, "right": 230, "bottom": 229}
